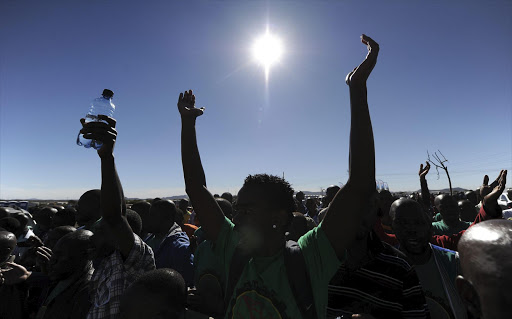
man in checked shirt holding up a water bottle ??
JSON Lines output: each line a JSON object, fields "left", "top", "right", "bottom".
{"left": 78, "top": 115, "right": 155, "bottom": 319}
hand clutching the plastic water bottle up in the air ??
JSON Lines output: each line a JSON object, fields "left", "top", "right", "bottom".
{"left": 80, "top": 115, "right": 117, "bottom": 158}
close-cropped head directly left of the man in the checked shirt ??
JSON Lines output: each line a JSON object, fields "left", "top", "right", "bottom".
{"left": 48, "top": 229, "right": 94, "bottom": 281}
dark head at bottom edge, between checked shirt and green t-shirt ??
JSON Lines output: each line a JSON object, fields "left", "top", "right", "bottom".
{"left": 121, "top": 268, "right": 187, "bottom": 319}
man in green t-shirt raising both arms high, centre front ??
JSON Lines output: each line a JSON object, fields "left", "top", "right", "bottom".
{"left": 178, "top": 36, "right": 384, "bottom": 318}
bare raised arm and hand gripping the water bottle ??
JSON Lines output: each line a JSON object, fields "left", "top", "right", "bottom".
{"left": 81, "top": 115, "right": 134, "bottom": 258}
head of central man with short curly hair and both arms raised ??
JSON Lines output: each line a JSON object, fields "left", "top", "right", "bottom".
{"left": 233, "top": 174, "right": 296, "bottom": 252}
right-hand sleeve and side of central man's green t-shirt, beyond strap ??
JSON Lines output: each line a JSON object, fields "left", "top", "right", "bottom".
{"left": 298, "top": 224, "right": 341, "bottom": 318}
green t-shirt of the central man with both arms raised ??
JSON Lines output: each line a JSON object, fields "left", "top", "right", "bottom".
{"left": 214, "top": 219, "right": 341, "bottom": 319}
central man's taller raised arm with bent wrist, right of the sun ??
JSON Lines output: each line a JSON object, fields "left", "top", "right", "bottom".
{"left": 322, "top": 34, "right": 379, "bottom": 259}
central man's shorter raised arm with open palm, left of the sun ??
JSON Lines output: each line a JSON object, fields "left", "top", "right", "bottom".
{"left": 178, "top": 90, "right": 224, "bottom": 241}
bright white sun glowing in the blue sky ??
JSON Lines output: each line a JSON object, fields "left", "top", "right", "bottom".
{"left": 252, "top": 29, "right": 284, "bottom": 80}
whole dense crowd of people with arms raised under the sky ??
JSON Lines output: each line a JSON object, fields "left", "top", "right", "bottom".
{"left": 0, "top": 35, "right": 512, "bottom": 319}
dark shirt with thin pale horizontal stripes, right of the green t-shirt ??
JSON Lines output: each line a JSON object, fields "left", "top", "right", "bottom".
{"left": 327, "top": 236, "right": 430, "bottom": 318}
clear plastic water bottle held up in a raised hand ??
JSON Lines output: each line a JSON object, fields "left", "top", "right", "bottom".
{"left": 76, "top": 89, "right": 116, "bottom": 150}
